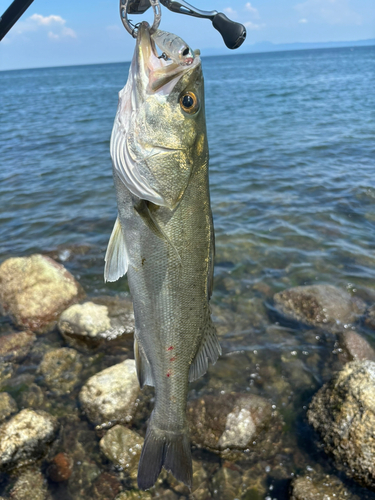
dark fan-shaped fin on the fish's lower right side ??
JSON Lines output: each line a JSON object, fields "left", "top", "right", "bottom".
{"left": 189, "top": 317, "right": 221, "bottom": 382}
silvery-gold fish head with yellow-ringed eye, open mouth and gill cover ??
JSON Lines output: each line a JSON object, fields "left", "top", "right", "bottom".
{"left": 111, "top": 23, "right": 208, "bottom": 209}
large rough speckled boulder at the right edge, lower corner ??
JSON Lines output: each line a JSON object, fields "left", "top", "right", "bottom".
{"left": 307, "top": 361, "right": 375, "bottom": 488}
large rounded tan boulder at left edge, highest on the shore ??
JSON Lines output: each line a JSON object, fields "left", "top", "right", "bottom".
{"left": 0, "top": 254, "right": 83, "bottom": 333}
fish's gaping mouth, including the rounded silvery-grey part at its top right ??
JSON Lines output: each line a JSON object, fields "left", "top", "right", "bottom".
{"left": 137, "top": 22, "right": 200, "bottom": 94}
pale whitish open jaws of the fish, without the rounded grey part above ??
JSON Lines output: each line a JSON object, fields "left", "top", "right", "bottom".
{"left": 137, "top": 22, "right": 200, "bottom": 95}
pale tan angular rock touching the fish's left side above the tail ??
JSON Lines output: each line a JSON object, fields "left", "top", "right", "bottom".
{"left": 79, "top": 359, "right": 140, "bottom": 427}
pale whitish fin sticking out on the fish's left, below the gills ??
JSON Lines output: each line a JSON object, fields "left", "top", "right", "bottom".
{"left": 104, "top": 217, "right": 129, "bottom": 281}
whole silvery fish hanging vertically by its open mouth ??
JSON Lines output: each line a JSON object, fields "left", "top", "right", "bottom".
{"left": 104, "top": 22, "right": 221, "bottom": 490}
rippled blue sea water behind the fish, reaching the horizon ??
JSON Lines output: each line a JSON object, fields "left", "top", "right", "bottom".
{"left": 0, "top": 47, "right": 375, "bottom": 500}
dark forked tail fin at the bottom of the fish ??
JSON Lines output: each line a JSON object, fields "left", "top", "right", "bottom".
{"left": 138, "top": 418, "right": 193, "bottom": 490}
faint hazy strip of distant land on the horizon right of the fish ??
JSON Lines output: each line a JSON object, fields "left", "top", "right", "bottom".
{"left": 206, "top": 38, "right": 375, "bottom": 56}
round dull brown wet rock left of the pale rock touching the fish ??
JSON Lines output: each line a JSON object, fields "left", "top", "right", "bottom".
{"left": 38, "top": 347, "right": 82, "bottom": 395}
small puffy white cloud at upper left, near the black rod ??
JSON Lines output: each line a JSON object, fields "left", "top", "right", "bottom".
{"left": 11, "top": 14, "right": 77, "bottom": 40}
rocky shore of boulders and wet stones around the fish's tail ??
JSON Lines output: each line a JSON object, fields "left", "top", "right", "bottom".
{"left": 0, "top": 255, "right": 375, "bottom": 500}
